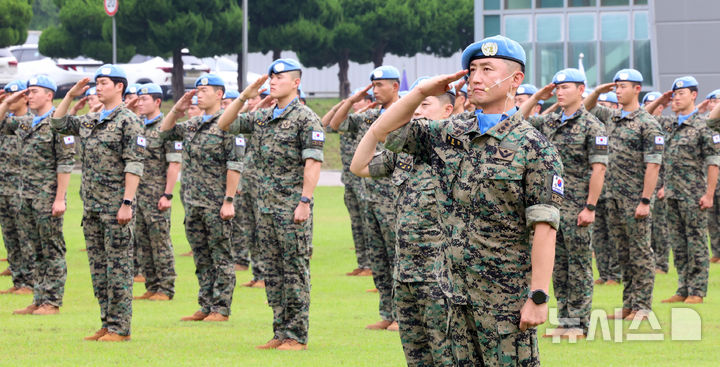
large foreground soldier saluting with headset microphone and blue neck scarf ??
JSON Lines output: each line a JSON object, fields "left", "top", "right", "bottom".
{"left": 376, "top": 36, "right": 564, "bottom": 366}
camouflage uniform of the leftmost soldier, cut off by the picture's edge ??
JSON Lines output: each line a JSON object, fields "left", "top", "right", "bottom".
{"left": 0, "top": 112, "right": 35, "bottom": 288}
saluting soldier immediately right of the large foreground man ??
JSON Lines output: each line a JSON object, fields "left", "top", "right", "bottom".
{"left": 520, "top": 69, "right": 608, "bottom": 338}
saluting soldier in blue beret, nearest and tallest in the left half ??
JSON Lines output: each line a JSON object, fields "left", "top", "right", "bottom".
{"left": 220, "top": 59, "right": 325, "bottom": 350}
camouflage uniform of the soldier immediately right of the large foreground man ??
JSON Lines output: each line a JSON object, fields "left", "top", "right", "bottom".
{"left": 528, "top": 105, "right": 608, "bottom": 334}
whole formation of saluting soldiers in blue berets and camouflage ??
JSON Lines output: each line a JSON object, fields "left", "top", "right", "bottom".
{"left": 0, "top": 36, "right": 720, "bottom": 366}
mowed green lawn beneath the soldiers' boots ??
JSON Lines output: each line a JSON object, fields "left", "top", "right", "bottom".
{"left": 0, "top": 175, "right": 720, "bottom": 367}
